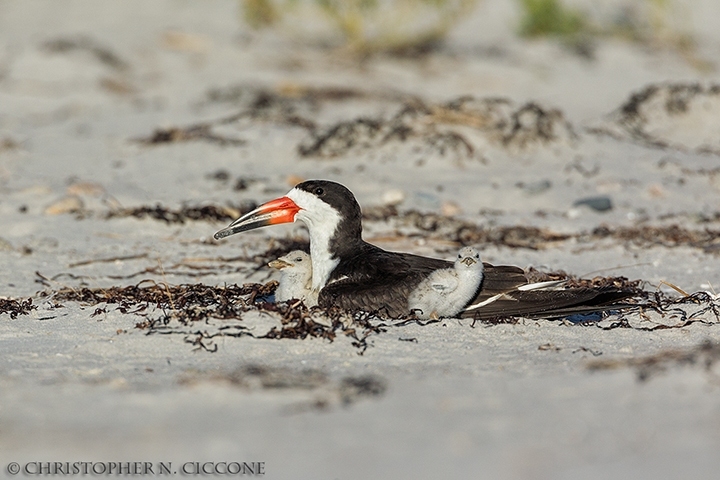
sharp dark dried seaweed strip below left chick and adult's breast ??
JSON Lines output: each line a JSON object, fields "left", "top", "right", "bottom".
{"left": 43, "top": 280, "right": 384, "bottom": 354}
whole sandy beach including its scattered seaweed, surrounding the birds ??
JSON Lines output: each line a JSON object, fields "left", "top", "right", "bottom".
{"left": 0, "top": 0, "right": 720, "bottom": 479}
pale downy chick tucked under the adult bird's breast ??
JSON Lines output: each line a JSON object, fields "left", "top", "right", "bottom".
{"left": 268, "top": 250, "right": 317, "bottom": 307}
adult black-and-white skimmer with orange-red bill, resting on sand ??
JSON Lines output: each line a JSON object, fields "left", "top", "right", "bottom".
{"left": 215, "top": 180, "right": 631, "bottom": 318}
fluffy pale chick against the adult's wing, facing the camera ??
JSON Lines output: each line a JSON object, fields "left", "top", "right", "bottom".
{"left": 408, "top": 247, "right": 484, "bottom": 320}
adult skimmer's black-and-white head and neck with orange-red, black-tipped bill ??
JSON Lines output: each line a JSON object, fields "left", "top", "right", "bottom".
{"left": 215, "top": 180, "right": 362, "bottom": 291}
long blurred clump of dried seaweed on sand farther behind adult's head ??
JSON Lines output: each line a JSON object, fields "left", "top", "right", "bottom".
{"left": 138, "top": 85, "right": 577, "bottom": 161}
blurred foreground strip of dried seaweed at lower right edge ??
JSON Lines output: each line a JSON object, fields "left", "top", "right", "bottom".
{"left": 587, "top": 340, "right": 720, "bottom": 382}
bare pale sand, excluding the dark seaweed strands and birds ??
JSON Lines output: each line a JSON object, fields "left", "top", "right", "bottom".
{"left": 0, "top": 0, "right": 720, "bottom": 479}
